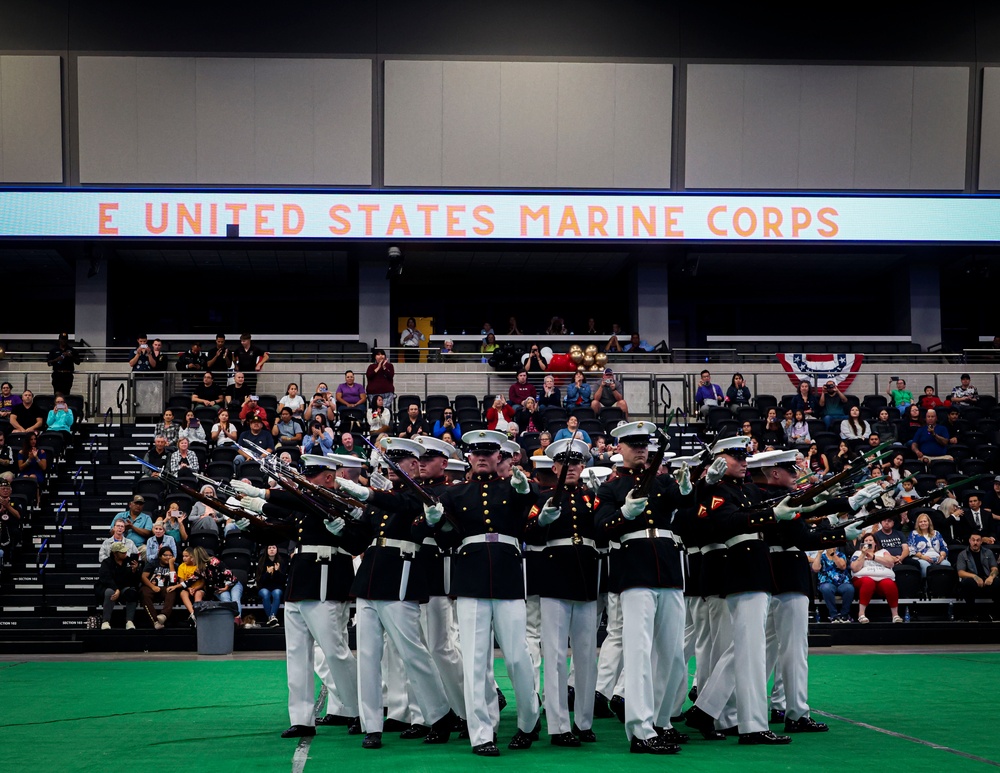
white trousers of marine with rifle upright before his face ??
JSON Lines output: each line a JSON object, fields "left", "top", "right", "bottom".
{"left": 541, "top": 598, "right": 597, "bottom": 735}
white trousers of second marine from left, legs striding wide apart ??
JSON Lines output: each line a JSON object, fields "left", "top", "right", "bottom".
{"left": 357, "top": 599, "right": 448, "bottom": 733}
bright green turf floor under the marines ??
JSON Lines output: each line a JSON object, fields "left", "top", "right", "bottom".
{"left": 0, "top": 653, "right": 1000, "bottom": 773}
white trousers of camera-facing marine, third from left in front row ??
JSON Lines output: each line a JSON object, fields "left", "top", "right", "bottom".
{"left": 455, "top": 597, "right": 539, "bottom": 746}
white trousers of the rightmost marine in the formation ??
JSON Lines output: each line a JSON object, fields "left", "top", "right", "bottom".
{"left": 769, "top": 593, "right": 809, "bottom": 719}
